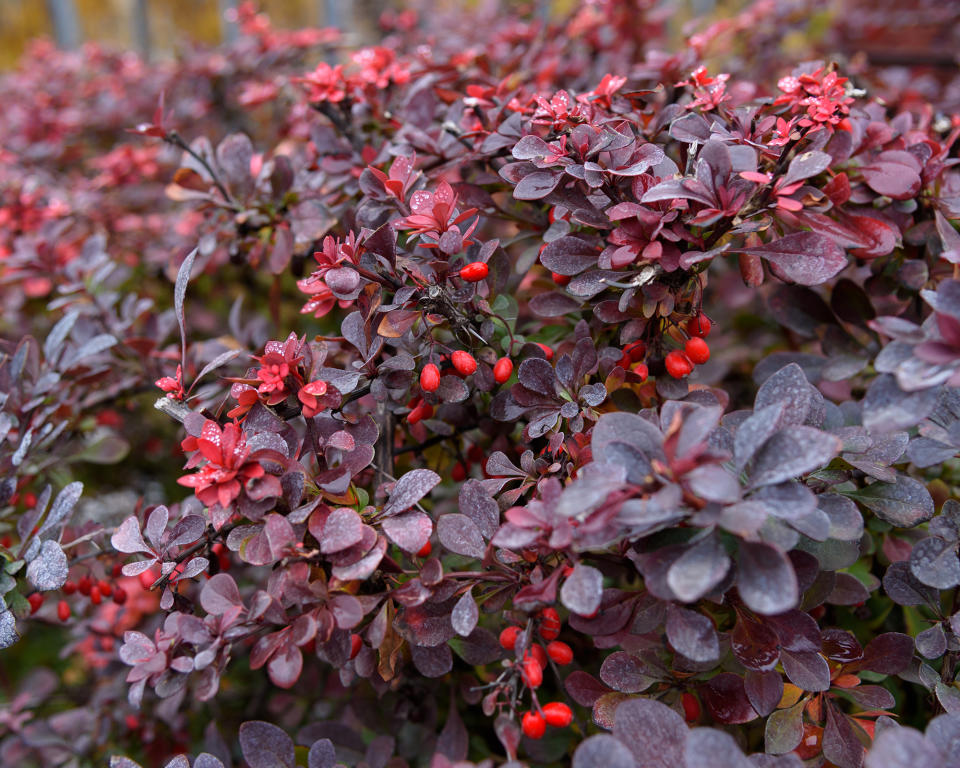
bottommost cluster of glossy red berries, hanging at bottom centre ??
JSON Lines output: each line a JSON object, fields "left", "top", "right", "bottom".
{"left": 500, "top": 608, "right": 573, "bottom": 739}
